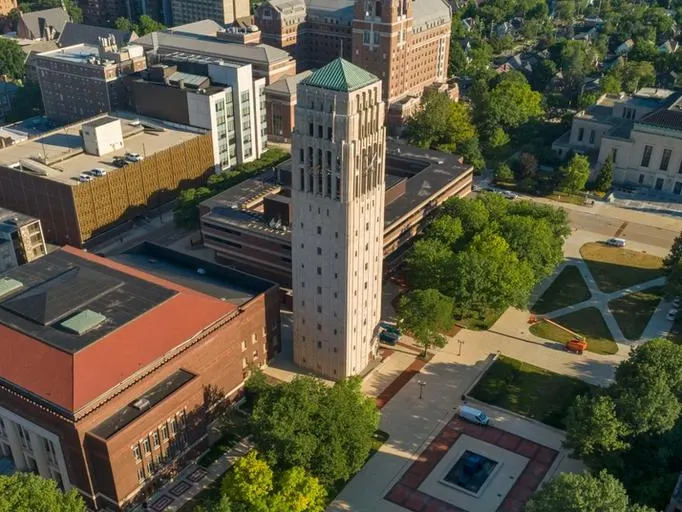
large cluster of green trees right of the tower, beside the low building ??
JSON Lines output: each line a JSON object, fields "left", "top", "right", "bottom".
{"left": 406, "top": 193, "right": 570, "bottom": 316}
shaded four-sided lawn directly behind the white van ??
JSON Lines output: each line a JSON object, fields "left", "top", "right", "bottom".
{"left": 471, "top": 356, "right": 592, "bottom": 429}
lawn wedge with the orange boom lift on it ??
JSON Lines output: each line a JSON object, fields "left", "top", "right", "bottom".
{"left": 529, "top": 308, "right": 618, "bottom": 354}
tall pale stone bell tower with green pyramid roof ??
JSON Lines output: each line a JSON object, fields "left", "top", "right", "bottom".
{"left": 291, "top": 58, "right": 386, "bottom": 379}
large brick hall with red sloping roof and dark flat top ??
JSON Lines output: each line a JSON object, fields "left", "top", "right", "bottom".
{"left": 0, "top": 246, "right": 280, "bottom": 511}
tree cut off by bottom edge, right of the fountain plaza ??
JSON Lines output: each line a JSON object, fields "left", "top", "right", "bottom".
{"left": 524, "top": 471, "right": 653, "bottom": 512}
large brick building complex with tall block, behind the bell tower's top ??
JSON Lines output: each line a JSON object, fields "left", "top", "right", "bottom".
{"left": 256, "top": 0, "right": 452, "bottom": 123}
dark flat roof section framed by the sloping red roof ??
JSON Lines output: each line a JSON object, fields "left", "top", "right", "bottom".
{"left": 0, "top": 247, "right": 177, "bottom": 354}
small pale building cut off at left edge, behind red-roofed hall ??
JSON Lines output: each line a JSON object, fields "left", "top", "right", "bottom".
{"left": 0, "top": 208, "right": 47, "bottom": 273}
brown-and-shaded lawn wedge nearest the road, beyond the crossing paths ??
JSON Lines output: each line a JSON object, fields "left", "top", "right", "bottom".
{"left": 580, "top": 242, "right": 663, "bottom": 293}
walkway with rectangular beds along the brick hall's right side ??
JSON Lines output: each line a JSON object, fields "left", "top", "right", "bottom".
{"left": 135, "top": 438, "right": 253, "bottom": 512}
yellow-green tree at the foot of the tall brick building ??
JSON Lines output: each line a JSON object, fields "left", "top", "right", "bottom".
{"left": 407, "top": 93, "right": 476, "bottom": 152}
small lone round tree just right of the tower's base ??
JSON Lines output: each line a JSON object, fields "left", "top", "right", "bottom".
{"left": 398, "top": 289, "right": 452, "bottom": 357}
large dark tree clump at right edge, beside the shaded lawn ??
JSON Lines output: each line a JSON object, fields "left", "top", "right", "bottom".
{"left": 566, "top": 339, "right": 682, "bottom": 510}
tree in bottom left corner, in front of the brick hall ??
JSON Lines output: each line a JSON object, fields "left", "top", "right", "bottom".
{"left": 0, "top": 473, "right": 87, "bottom": 512}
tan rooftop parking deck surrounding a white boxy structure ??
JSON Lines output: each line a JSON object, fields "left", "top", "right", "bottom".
{"left": 0, "top": 112, "right": 203, "bottom": 186}
